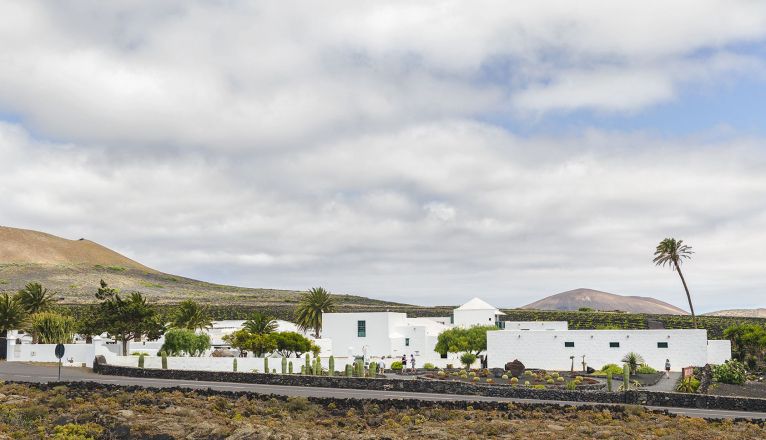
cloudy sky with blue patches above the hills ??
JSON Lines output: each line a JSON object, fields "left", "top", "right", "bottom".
{"left": 0, "top": 0, "right": 766, "bottom": 312}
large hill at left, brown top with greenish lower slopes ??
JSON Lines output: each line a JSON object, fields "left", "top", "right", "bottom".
{"left": 0, "top": 226, "right": 410, "bottom": 310}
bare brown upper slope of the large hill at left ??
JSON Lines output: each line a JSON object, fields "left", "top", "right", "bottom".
{"left": 0, "top": 226, "right": 156, "bottom": 272}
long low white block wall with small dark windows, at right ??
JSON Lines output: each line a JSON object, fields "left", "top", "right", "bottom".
{"left": 487, "top": 330, "right": 708, "bottom": 370}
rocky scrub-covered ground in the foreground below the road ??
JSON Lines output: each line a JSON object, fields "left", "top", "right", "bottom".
{"left": 0, "top": 383, "right": 766, "bottom": 440}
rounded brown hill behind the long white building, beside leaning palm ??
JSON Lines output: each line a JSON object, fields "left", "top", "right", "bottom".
{"left": 522, "top": 288, "right": 688, "bottom": 315}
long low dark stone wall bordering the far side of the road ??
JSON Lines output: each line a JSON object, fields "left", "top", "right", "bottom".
{"left": 93, "top": 358, "right": 766, "bottom": 412}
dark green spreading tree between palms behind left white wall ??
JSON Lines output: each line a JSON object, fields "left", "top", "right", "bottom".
{"left": 96, "top": 280, "right": 165, "bottom": 356}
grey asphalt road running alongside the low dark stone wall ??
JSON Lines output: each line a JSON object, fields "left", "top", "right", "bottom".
{"left": 0, "top": 361, "right": 766, "bottom": 419}
